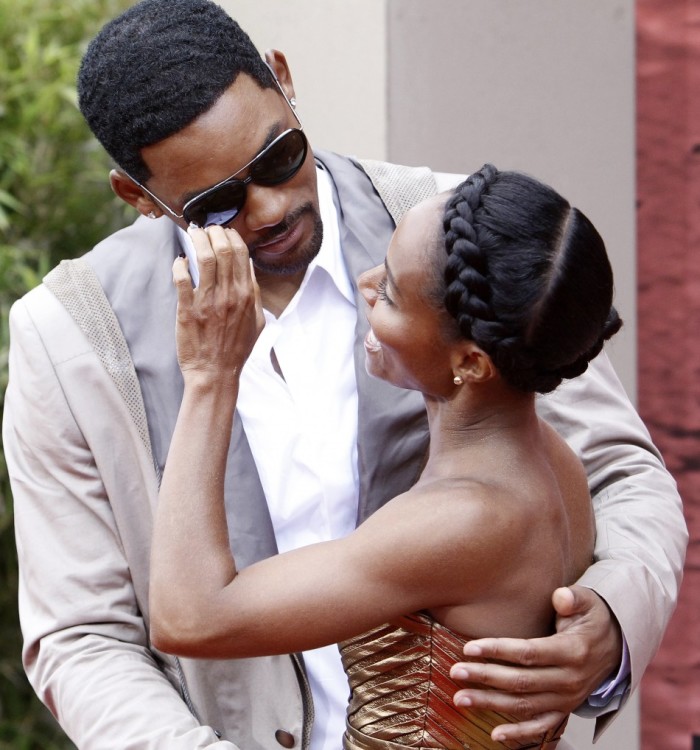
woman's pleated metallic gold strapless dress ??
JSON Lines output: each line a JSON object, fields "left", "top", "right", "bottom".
{"left": 340, "top": 613, "right": 566, "bottom": 750}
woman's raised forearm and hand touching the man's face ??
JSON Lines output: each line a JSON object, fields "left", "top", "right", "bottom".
{"left": 149, "top": 227, "right": 263, "bottom": 649}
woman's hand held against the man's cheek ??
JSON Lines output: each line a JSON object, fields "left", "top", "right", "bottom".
{"left": 173, "top": 226, "right": 265, "bottom": 382}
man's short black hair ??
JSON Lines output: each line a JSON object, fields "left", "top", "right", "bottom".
{"left": 78, "top": 0, "right": 274, "bottom": 182}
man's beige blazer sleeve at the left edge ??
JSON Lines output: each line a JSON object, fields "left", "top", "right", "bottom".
{"left": 3, "top": 292, "right": 241, "bottom": 750}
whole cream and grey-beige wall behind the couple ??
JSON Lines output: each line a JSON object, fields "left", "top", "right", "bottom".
{"left": 221, "top": 0, "right": 639, "bottom": 750}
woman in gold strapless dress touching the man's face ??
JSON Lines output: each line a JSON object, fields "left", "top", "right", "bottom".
{"left": 151, "top": 165, "right": 621, "bottom": 750}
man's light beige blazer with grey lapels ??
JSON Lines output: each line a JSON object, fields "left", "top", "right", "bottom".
{"left": 3, "top": 155, "right": 687, "bottom": 750}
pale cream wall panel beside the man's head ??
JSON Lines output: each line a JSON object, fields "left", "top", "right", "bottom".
{"left": 227, "top": 0, "right": 389, "bottom": 159}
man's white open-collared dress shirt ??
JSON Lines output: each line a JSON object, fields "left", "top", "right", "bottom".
{"left": 238, "top": 169, "right": 359, "bottom": 750}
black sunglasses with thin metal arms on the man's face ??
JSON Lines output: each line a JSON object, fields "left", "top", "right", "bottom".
{"left": 133, "top": 128, "right": 309, "bottom": 227}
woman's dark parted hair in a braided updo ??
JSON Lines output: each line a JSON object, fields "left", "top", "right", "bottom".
{"left": 443, "top": 164, "right": 622, "bottom": 393}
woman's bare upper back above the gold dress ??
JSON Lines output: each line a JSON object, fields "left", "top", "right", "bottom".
{"left": 416, "top": 420, "right": 595, "bottom": 638}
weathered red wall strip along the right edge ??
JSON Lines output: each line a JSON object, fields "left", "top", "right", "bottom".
{"left": 637, "top": 0, "right": 700, "bottom": 750}
